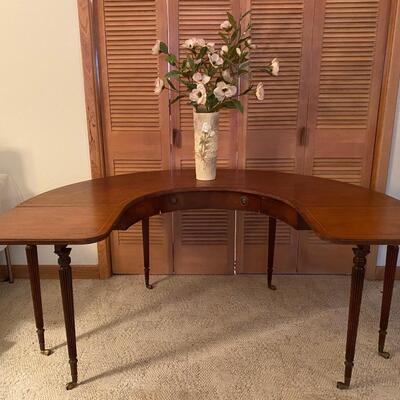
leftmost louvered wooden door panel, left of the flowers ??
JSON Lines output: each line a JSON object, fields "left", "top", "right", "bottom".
{"left": 96, "top": 0, "right": 172, "bottom": 273}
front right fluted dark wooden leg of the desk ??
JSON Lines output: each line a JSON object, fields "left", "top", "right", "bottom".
{"left": 337, "top": 245, "right": 369, "bottom": 389}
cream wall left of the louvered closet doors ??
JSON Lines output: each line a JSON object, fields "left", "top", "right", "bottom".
{"left": 0, "top": 0, "right": 97, "bottom": 264}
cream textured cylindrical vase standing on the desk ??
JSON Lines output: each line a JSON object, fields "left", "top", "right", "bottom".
{"left": 193, "top": 111, "right": 219, "bottom": 181}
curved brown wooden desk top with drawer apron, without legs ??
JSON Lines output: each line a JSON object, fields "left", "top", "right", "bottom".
{"left": 0, "top": 170, "right": 400, "bottom": 244}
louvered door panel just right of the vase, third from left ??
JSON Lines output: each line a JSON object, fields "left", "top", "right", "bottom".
{"left": 234, "top": 0, "right": 314, "bottom": 273}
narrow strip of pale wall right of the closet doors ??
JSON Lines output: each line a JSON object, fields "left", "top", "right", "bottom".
{"left": 377, "top": 88, "right": 400, "bottom": 266}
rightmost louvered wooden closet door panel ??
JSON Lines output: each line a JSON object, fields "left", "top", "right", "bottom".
{"left": 298, "top": 0, "right": 389, "bottom": 273}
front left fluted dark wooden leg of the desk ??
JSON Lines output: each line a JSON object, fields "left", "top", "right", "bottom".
{"left": 54, "top": 245, "right": 78, "bottom": 390}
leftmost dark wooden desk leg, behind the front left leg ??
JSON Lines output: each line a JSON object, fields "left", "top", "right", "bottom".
{"left": 25, "top": 245, "right": 52, "bottom": 356}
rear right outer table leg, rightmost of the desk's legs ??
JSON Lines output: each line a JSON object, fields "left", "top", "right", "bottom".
{"left": 378, "top": 245, "right": 399, "bottom": 358}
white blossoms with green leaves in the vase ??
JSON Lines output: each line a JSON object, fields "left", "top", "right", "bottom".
{"left": 152, "top": 11, "right": 279, "bottom": 113}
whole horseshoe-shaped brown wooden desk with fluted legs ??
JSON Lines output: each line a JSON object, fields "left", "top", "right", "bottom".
{"left": 0, "top": 170, "right": 400, "bottom": 389}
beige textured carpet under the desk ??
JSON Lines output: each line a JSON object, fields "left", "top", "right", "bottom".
{"left": 0, "top": 276, "right": 400, "bottom": 400}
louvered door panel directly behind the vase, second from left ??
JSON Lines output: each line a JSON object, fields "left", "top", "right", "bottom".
{"left": 170, "top": 0, "right": 239, "bottom": 274}
